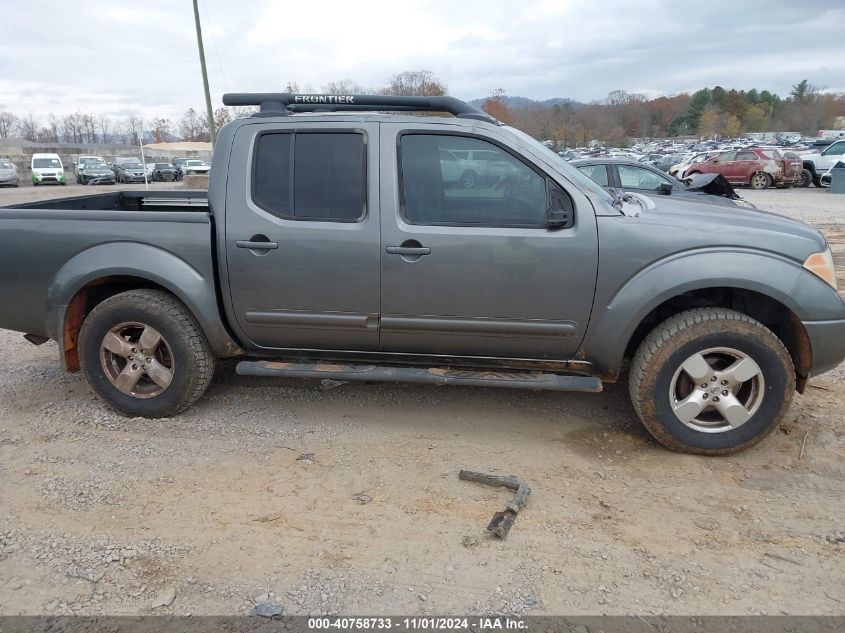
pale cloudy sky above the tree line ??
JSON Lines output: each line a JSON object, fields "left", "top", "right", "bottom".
{"left": 0, "top": 0, "right": 845, "bottom": 119}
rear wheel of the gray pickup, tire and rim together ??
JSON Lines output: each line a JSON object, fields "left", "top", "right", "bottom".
{"left": 79, "top": 290, "right": 215, "bottom": 418}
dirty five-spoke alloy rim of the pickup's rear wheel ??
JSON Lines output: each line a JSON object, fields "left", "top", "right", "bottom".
{"left": 100, "top": 322, "right": 175, "bottom": 398}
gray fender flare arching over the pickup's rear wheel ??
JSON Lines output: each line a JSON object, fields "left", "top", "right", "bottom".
{"left": 45, "top": 242, "right": 242, "bottom": 369}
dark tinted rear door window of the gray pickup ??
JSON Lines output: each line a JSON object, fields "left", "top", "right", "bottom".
{"left": 252, "top": 132, "right": 365, "bottom": 222}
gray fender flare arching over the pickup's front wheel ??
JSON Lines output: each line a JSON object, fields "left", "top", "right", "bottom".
{"left": 582, "top": 248, "right": 806, "bottom": 377}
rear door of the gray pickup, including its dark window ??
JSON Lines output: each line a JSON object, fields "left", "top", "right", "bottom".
{"left": 225, "top": 120, "right": 379, "bottom": 351}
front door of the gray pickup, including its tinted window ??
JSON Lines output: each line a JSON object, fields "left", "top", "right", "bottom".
{"left": 380, "top": 123, "right": 598, "bottom": 360}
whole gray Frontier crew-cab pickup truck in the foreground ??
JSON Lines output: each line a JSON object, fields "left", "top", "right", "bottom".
{"left": 0, "top": 93, "right": 845, "bottom": 454}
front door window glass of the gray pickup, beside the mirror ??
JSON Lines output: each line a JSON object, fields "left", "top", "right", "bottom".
{"left": 399, "top": 134, "right": 548, "bottom": 227}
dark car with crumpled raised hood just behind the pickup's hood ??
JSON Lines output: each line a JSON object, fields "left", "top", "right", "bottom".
{"left": 572, "top": 158, "right": 739, "bottom": 206}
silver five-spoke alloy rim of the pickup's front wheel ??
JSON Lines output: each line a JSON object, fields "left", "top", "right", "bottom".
{"left": 669, "top": 347, "right": 765, "bottom": 433}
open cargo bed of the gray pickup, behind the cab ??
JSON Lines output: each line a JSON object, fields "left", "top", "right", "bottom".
{"left": 0, "top": 191, "right": 220, "bottom": 339}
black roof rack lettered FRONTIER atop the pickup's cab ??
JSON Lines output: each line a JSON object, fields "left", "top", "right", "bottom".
{"left": 223, "top": 92, "right": 498, "bottom": 123}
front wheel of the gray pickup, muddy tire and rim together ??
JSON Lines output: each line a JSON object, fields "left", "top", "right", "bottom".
{"left": 629, "top": 308, "right": 795, "bottom": 455}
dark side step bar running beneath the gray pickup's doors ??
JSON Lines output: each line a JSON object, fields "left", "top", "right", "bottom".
{"left": 236, "top": 360, "right": 602, "bottom": 393}
